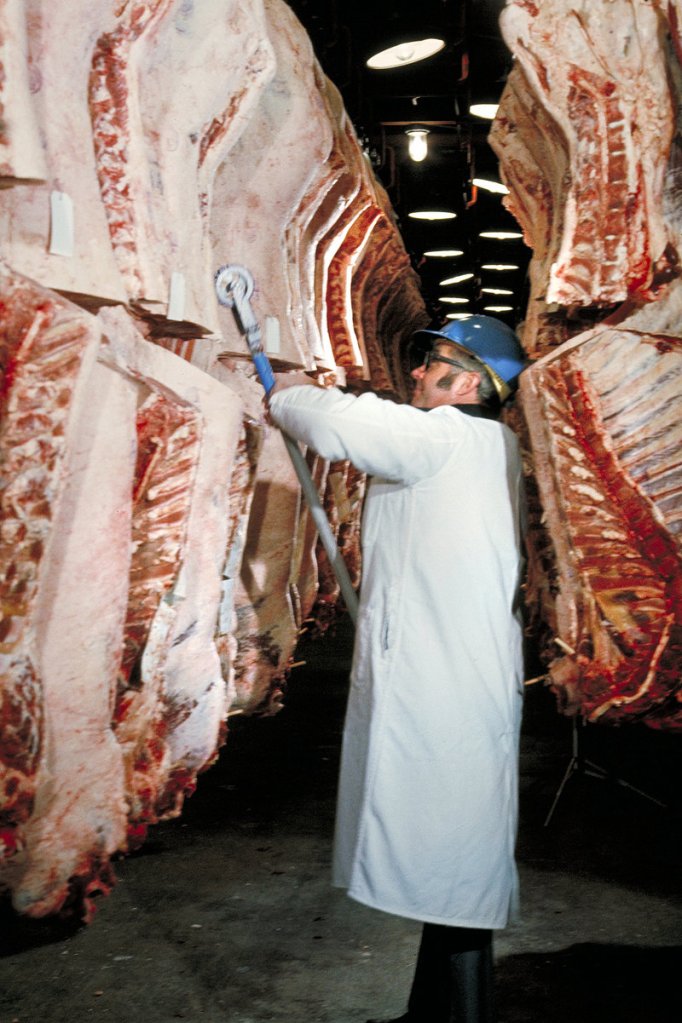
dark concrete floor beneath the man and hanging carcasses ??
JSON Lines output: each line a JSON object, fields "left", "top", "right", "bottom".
{"left": 0, "top": 613, "right": 682, "bottom": 1023}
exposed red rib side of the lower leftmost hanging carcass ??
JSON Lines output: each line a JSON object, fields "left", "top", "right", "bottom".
{"left": 0, "top": 271, "right": 97, "bottom": 842}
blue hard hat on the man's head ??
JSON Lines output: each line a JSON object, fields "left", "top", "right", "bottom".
{"left": 414, "top": 314, "right": 527, "bottom": 401}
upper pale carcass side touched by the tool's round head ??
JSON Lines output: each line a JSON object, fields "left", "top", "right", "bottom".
{"left": 211, "top": 0, "right": 333, "bottom": 368}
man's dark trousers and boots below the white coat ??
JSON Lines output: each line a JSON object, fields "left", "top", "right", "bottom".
{"left": 407, "top": 924, "right": 495, "bottom": 1023}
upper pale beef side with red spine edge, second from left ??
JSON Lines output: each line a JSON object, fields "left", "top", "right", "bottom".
{"left": 88, "top": 0, "right": 275, "bottom": 332}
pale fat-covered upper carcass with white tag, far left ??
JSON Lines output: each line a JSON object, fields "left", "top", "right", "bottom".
{"left": 0, "top": 0, "right": 126, "bottom": 303}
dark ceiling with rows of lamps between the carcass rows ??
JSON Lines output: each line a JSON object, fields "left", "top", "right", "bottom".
{"left": 288, "top": 0, "right": 531, "bottom": 326}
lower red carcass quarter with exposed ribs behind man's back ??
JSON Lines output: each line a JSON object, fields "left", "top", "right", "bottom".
{"left": 522, "top": 329, "right": 682, "bottom": 728}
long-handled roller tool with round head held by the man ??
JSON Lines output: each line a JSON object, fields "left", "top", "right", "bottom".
{"left": 215, "top": 264, "right": 358, "bottom": 624}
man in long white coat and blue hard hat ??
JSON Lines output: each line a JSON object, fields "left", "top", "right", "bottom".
{"left": 270, "top": 316, "right": 524, "bottom": 1023}
